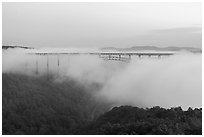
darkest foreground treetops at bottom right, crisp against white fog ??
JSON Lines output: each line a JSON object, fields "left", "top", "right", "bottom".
{"left": 81, "top": 106, "right": 202, "bottom": 135}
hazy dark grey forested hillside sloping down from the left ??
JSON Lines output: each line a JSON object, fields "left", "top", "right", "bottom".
{"left": 2, "top": 74, "right": 107, "bottom": 134}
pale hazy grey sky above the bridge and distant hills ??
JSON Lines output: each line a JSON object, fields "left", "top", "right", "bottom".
{"left": 2, "top": 2, "right": 202, "bottom": 48}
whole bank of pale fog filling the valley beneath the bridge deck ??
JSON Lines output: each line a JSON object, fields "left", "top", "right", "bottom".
{"left": 2, "top": 50, "right": 202, "bottom": 109}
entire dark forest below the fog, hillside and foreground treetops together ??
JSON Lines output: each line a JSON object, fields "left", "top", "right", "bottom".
{"left": 2, "top": 74, "right": 202, "bottom": 134}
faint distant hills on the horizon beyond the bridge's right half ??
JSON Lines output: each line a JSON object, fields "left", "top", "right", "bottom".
{"left": 101, "top": 46, "right": 202, "bottom": 53}
